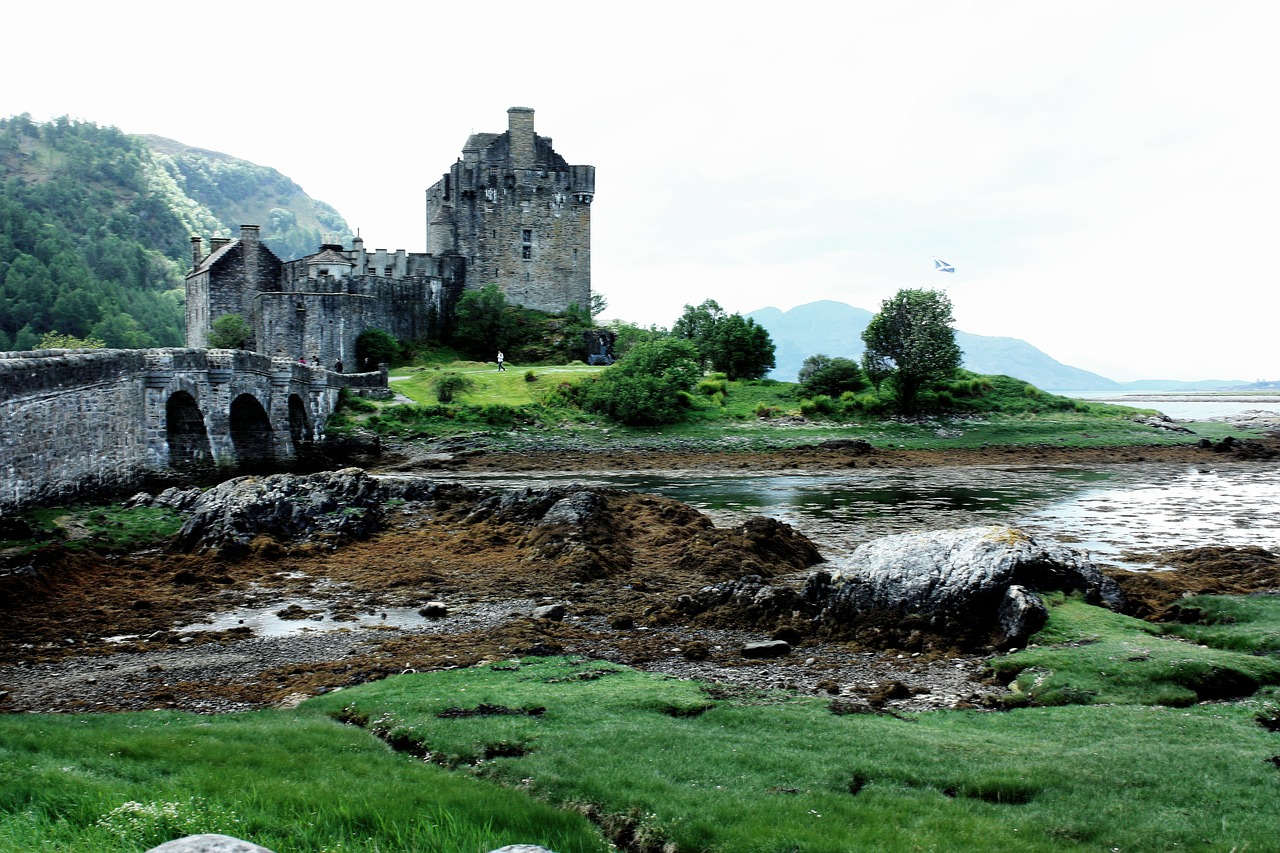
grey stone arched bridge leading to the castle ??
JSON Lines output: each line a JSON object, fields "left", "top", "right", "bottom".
{"left": 0, "top": 348, "right": 387, "bottom": 508}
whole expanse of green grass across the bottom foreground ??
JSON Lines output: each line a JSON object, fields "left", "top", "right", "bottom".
{"left": 0, "top": 648, "right": 1280, "bottom": 853}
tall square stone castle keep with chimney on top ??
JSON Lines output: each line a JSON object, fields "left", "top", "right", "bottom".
{"left": 426, "top": 106, "right": 595, "bottom": 311}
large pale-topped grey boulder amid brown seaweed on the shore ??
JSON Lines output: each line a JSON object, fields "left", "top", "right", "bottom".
{"left": 804, "top": 526, "right": 1124, "bottom": 649}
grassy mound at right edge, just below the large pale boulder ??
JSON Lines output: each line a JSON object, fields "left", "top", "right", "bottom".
{"left": 991, "top": 597, "right": 1280, "bottom": 707}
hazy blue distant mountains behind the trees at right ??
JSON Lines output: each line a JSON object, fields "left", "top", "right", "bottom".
{"left": 745, "top": 300, "right": 1244, "bottom": 393}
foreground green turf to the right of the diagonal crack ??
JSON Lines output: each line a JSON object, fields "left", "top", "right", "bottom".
{"left": 305, "top": 660, "right": 1280, "bottom": 853}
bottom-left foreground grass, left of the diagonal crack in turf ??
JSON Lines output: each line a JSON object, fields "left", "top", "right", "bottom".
{"left": 0, "top": 711, "right": 604, "bottom": 853}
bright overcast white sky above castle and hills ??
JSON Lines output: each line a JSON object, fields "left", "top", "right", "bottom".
{"left": 0, "top": 0, "right": 1280, "bottom": 382}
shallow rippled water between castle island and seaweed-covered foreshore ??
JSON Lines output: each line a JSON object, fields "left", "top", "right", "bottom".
{"left": 427, "top": 462, "right": 1280, "bottom": 566}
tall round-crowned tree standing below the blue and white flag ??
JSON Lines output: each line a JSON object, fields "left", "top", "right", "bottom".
{"left": 863, "top": 288, "right": 961, "bottom": 414}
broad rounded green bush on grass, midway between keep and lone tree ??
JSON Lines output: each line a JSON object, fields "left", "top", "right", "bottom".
{"left": 584, "top": 338, "right": 703, "bottom": 427}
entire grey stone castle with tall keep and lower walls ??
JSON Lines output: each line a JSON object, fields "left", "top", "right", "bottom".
{"left": 187, "top": 106, "right": 595, "bottom": 369}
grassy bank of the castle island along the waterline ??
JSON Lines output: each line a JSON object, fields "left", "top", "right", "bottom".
{"left": 322, "top": 362, "right": 1251, "bottom": 452}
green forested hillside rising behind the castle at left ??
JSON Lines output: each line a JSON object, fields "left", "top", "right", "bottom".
{"left": 0, "top": 115, "right": 349, "bottom": 351}
